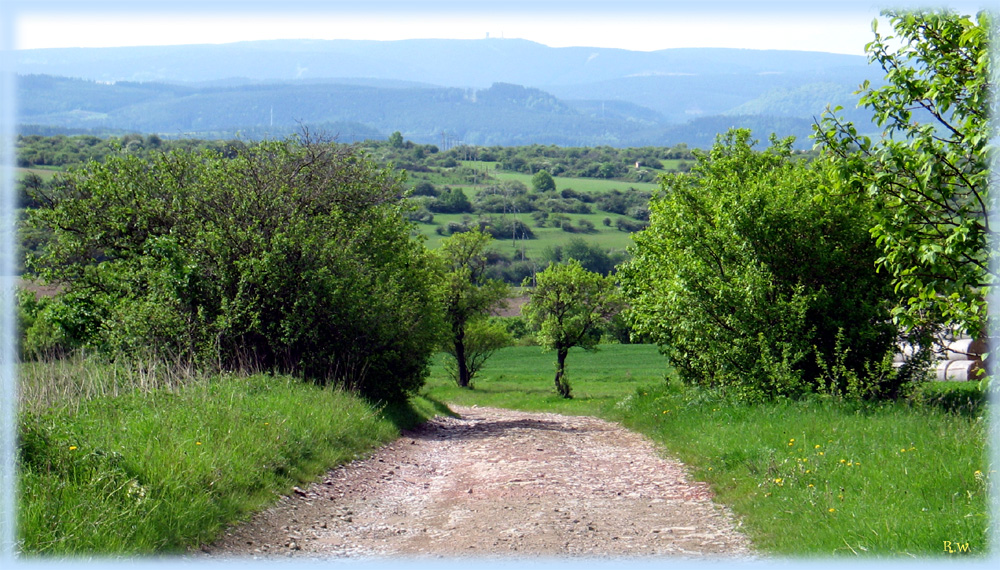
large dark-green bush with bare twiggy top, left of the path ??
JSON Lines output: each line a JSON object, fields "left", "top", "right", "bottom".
{"left": 29, "top": 134, "right": 439, "bottom": 399}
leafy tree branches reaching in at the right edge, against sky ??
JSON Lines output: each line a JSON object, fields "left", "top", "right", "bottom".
{"left": 816, "top": 11, "right": 997, "bottom": 342}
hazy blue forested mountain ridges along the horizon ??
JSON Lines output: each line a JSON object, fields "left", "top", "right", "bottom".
{"left": 16, "top": 39, "right": 881, "bottom": 147}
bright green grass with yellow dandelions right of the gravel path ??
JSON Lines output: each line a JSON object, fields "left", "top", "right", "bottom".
{"left": 425, "top": 345, "right": 992, "bottom": 557}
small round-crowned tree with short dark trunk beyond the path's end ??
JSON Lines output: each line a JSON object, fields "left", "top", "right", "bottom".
{"left": 521, "top": 259, "right": 623, "bottom": 398}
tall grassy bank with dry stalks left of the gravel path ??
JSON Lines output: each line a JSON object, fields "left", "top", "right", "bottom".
{"left": 17, "top": 366, "right": 439, "bottom": 556}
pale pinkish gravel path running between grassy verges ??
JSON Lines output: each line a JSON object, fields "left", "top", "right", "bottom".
{"left": 198, "top": 407, "right": 754, "bottom": 559}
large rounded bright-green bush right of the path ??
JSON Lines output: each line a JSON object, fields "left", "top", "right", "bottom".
{"left": 618, "top": 130, "right": 905, "bottom": 400}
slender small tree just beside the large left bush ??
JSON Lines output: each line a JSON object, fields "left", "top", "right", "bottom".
{"left": 437, "top": 230, "right": 510, "bottom": 388}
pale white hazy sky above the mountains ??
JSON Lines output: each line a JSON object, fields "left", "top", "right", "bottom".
{"left": 10, "top": 0, "right": 968, "bottom": 55}
